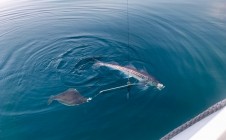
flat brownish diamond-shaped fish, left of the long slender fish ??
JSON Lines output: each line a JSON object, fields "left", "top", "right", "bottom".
{"left": 48, "top": 88, "right": 91, "bottom": 106}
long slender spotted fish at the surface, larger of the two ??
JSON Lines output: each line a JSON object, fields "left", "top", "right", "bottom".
{"left": 96, "top": 61, "right": 165, "bottom": 90}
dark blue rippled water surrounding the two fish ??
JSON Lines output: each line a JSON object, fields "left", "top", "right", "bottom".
{"left": 0, "top": 0, "right": 226, "bottom": 140}
